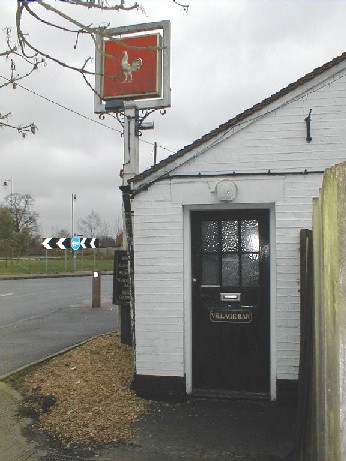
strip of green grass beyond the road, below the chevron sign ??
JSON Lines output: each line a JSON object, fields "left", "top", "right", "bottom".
{"left": 0, "top": 251, "right": 113, "bottom": 275}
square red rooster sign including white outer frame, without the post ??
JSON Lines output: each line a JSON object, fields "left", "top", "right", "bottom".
{"left": 94, "top": 21, "right": 171, "bottom": 114}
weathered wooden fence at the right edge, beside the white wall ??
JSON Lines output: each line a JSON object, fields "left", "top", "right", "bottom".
{"left": 297, "top": 162, "right": 346, "bottom": 461}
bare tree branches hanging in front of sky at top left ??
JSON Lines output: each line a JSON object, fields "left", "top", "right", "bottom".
{"left": 0, "top": 0, "right": 189, "bottom": 137}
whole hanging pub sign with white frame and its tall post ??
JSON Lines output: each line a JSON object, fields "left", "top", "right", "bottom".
{"left": 94, "top": 21, "right": 171, "bottom": 344}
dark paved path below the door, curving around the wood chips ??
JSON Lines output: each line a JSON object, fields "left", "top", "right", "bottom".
{"left": 0, "top": 382, "right": 296, "bottom": 461}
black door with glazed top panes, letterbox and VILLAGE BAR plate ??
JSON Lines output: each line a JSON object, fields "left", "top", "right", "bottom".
{"left": 191, "top": 210, "right": 270, "bottom": 396}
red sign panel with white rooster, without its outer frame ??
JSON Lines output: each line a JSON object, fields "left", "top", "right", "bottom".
{"left": 101, "top": 33, "right": 162, "bottom": 100}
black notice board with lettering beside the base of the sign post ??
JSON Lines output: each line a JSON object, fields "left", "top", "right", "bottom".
{"left": 113, "top": 250, "right": 130, "bottom": 304}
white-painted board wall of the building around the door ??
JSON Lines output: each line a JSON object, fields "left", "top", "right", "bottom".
{"left": 134, "top": 69, "right": 346, "bottom": 379}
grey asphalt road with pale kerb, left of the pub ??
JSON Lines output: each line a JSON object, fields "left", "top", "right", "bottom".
{"left": 0, "top": 275, "right": 117, "bottom": 377}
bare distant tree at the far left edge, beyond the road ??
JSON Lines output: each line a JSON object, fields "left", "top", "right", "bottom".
{"left": 0, "top": 193, "right": 38, "bottom": 258}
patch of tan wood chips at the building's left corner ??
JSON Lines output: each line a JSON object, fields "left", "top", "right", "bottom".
{"left": 13, "top": 333, "right": 149, "bottom": 448}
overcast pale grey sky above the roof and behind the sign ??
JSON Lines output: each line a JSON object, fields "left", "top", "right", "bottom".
{"left": 0, "top": 0, "right": 346, "bottom": 237}
